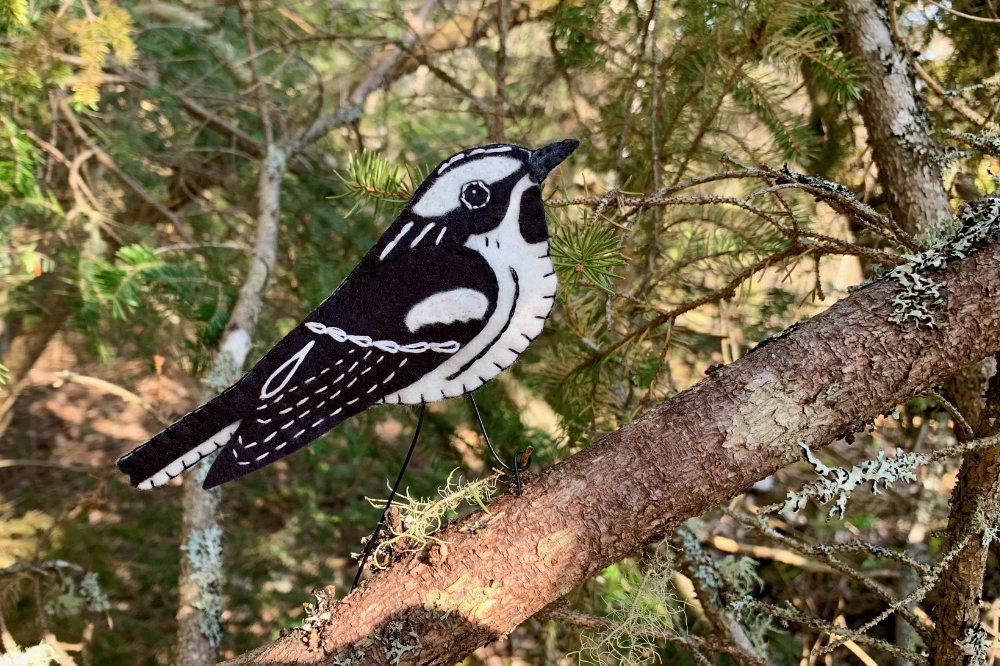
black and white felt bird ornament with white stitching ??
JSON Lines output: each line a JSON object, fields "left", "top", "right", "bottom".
{"left": 118, "top": 139, "right": 580, "bottom": 489}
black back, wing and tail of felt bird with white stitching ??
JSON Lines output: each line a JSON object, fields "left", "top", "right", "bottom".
{"left": 118, "top": 243, "right": 497, "bottom": 488}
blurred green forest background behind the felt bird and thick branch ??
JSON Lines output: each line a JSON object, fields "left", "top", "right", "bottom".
{"left": 0, "top": 0, "right": 1000, "bottom": 665}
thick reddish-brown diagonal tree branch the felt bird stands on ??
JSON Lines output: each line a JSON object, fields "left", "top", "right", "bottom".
{"left": 221, "top": 205, "right": 1000, "bottom": 666}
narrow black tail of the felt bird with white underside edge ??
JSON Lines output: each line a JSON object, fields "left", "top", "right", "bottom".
{"left": 118, "top": 391, "right": 242, "bottom": 490}
